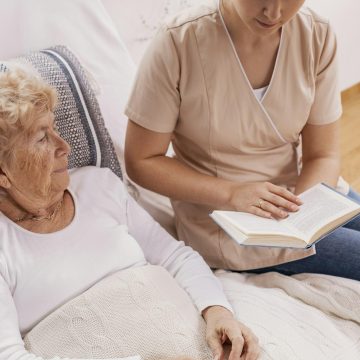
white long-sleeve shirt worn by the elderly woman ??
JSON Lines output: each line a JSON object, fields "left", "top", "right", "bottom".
{"left": 0, "top": 167, "right": 231, "bottom": 360}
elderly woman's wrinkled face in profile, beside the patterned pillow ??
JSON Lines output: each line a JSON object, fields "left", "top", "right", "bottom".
{"left": 2, "top": 112, "right": 70, "bottom": 208}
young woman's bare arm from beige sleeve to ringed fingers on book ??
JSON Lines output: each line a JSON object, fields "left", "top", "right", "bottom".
{"left": 125, "top": 120, "right": 298, "bottom": 218}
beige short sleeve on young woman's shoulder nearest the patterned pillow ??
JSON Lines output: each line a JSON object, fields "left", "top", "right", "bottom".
{"left": 125, "top": 27, "right": 180, "bottom": 133}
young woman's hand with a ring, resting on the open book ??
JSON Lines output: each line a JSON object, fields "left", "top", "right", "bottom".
{"left": 229, "top": 182, "right": 302, "bottom": 219}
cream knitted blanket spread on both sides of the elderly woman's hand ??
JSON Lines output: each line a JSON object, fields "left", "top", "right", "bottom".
{"left": 25, "top": 266, "right": 360, "bottom": 360}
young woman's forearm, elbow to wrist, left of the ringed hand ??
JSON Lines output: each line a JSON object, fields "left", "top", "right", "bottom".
{"left": 127, "top": 155, "right": 233, "bottom": 209}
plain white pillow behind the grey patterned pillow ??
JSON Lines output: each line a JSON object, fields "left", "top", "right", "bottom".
{"left": 0, "top": 0, "right": 135, "bottom": 155}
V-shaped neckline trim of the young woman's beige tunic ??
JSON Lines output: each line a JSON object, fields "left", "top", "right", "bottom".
{"left": 217, "top": 0, "right": 285, "bottom": 106}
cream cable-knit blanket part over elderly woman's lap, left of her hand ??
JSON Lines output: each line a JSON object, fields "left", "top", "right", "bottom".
{"left": 24, "top": 265, "right": 213, "bottom": 360}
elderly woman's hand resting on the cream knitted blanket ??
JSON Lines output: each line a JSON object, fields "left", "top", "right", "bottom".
{"left": 203, "top": 306, "right": 260, "bottom": 360}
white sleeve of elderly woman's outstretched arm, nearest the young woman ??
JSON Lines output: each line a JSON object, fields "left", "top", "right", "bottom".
{"left": 126, "top": 197, "right": 232, "bottom": 311}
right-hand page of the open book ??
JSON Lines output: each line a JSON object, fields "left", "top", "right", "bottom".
{"left": 285, "top": 184, "right": 357, "bottom": 240}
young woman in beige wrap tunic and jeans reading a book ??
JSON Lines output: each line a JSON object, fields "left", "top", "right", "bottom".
{"left": 125, "top": 0, "right": 360, "bottom": 279}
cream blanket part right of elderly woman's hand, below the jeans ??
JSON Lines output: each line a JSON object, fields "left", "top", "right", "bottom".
{"left": 216, "top": 270, "right": 360, "bottom": 360}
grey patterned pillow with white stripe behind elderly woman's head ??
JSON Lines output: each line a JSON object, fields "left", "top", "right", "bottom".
{"left": 0, "top": 46, "right": 122, "bottom": 178}
